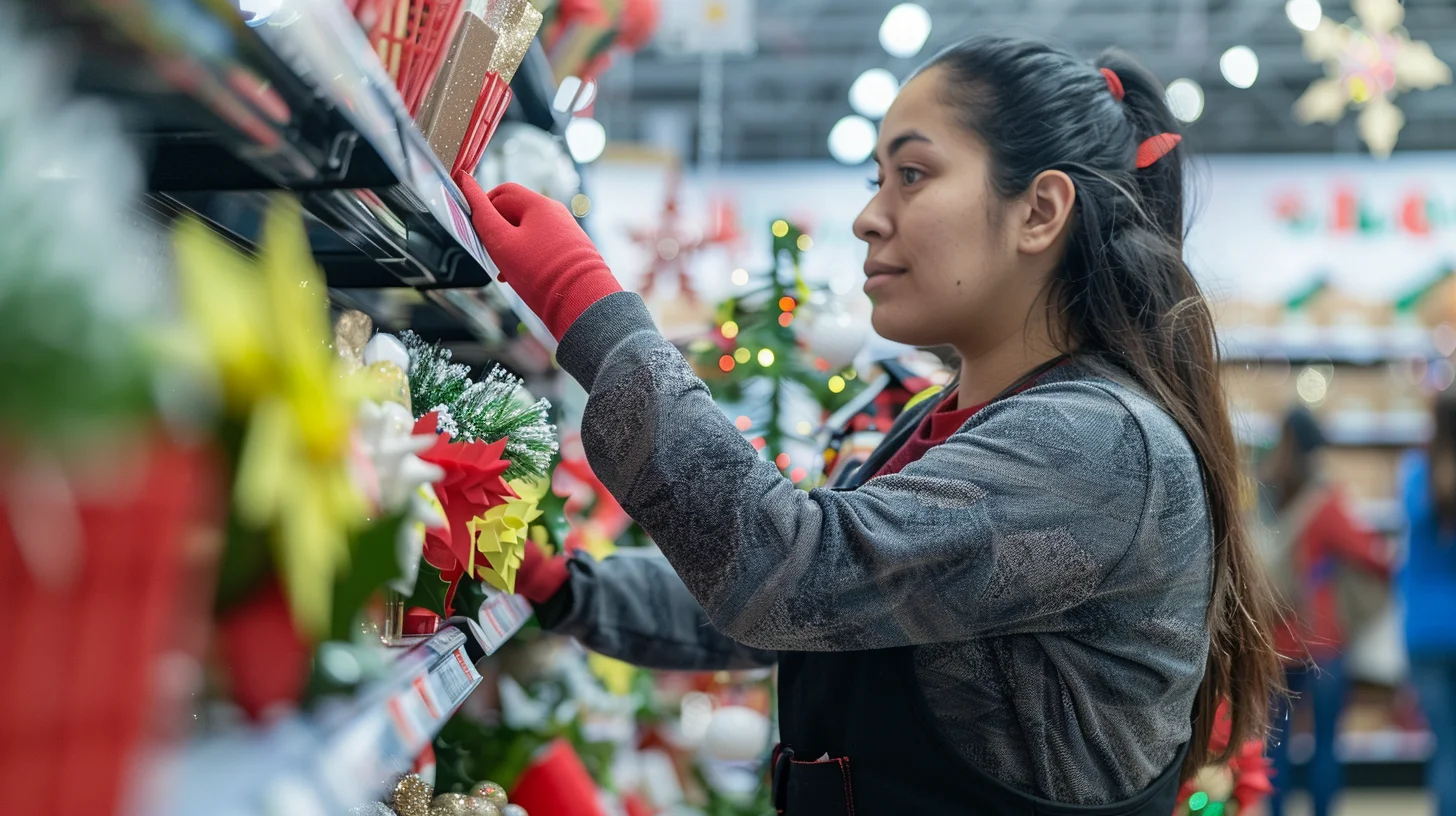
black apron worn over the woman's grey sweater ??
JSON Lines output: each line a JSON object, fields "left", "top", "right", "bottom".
{"left": 773, "top": 358, "right": 1187, "bottom": 816}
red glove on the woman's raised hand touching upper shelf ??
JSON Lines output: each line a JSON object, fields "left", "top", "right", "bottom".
{"left": 456, "top": 173, "right": 622, "bottom": 340}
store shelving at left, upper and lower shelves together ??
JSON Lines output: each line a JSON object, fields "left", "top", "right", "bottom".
{"left": 26, "top": 0, "right": 558, "bottom": 816}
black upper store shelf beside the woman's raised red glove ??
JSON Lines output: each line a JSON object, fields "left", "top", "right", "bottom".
{"left": 35, "top": 0, "right": 563, "bottom": 341}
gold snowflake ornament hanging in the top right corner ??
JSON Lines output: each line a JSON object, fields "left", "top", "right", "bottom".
{"left": 1294, "top": 0, "right": 1452, "bottom": 159}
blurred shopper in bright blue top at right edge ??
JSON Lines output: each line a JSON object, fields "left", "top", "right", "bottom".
{"left": 1401, "top": 392, "right": 1456, "bottom": 816}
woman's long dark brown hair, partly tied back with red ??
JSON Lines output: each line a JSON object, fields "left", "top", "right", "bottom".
{"left": 929, "top": 36, "right": 1283, "bottom": 778}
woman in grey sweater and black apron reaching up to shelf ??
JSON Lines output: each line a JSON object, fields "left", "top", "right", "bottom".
{"left": 460, "top": 38, "right": 1277, "bottom": 816}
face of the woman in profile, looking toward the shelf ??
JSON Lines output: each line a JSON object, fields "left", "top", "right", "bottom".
{"left": 855, "top": 68, "right": 1050, "bottom": 356}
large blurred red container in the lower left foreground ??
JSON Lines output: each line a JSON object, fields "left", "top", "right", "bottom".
{"left": 0, "top": 443, "right": 218, "bottom": 816}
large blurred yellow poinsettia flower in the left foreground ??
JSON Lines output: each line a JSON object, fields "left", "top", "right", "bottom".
{"left": 175, "top": 197, "right": 368, "bottom": 635}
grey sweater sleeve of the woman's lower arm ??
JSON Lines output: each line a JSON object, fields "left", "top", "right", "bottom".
{"left": 536, "top": 549, "right": 778, "bottom": 672}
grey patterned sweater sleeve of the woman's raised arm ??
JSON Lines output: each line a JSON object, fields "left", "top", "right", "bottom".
{"left": 558, "top": 293, "right": 1164, "bottom": 651}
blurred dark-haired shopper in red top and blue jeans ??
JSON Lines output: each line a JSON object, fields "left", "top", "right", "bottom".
{"left": 1259, "top": 408, "right": 1390, "bottom": 816}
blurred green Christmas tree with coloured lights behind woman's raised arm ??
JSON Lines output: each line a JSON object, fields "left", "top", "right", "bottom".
{"left": 689, "top": 219, "right": 863, "bottom": 482}
